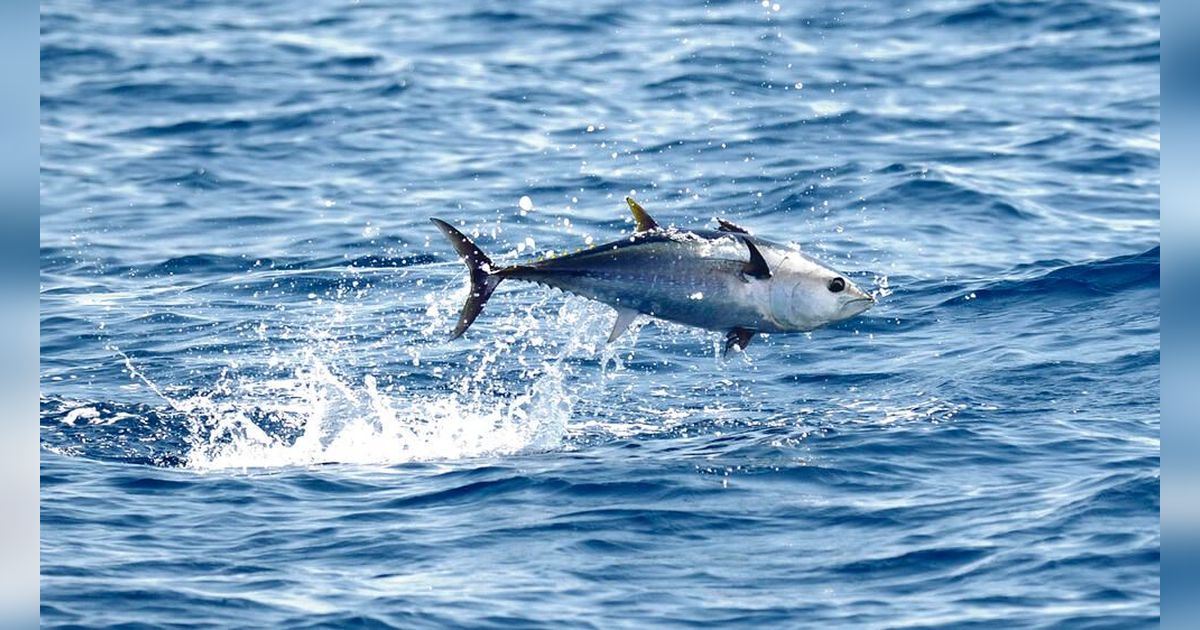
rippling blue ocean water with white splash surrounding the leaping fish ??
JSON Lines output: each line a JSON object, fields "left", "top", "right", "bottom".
{"left": 40, "top": 0, "right": 1159, "bottom": 629}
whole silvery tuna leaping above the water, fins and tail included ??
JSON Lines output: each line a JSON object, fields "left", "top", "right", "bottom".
{"left": 433, "top": 199, "right": 875, "bottom": 349}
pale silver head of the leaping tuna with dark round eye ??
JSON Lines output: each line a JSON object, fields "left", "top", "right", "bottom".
{"left": 770, "top": 256, "right": 875, "bottom": 331}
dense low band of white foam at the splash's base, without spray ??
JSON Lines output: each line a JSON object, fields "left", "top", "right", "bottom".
{"left": 179, "top": 356, "right": 571, "bottom": 469}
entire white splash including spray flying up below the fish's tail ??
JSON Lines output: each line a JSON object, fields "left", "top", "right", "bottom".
{"left": 113, "top": 282, "right": 636, "bottom": 470}
